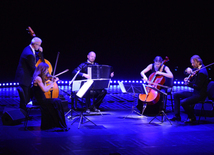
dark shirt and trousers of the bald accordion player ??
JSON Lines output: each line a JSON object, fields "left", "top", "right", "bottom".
{"left": 72, "top": 61, "right": 107, "bottom": 109}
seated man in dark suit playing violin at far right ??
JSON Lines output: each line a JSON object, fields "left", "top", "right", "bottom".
{"left": 171, "top": 55, "right": 208, "bottom": 123}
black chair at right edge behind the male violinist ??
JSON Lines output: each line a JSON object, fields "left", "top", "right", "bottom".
{"left": 198, "top": 81, "right": 214, "bottom": 123}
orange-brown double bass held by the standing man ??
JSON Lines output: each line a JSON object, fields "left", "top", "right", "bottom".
{"left": 27, "top": 26, "right": 59, "bottom": 98}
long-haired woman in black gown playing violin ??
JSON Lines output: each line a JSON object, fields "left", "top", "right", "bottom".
{"left": 32, "top": 62, "right": 68, "bottom": 131}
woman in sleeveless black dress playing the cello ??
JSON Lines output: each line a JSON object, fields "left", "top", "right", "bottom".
{"left": 140, "top": 56, "right": 173, "bottom": 110}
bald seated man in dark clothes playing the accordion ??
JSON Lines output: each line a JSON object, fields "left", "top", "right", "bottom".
{"left": 72, "top": 51, "right": 114, "bottom": 113}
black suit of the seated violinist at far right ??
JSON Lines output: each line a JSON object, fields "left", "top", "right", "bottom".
{"left": 173, "top": 65, "right": 209, "bottom": 120}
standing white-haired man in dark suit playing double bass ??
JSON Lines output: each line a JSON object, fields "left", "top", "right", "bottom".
{"left": 15, "top": 37, "right": 43, "bottom": 111}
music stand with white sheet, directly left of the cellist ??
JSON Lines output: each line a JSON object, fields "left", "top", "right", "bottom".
{"left": 118, "top": 82, "right": 145, "bottom": 119}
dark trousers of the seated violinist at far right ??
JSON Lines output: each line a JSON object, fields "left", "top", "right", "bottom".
{"left": 173, "top": 91, "right": 204, "bottom": 118}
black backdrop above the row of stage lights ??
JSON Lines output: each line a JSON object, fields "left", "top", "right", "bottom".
{"left": 0, "top": 1, "right": 214, "bottom": 82}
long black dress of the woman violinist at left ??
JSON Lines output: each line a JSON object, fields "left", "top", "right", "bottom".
{"left": 33, "top": 85, "right": 68, "bottom": 131}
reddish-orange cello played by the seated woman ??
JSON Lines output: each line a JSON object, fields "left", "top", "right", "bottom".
{"left": 139, "top": 57, "right": 169, "bottom": 105}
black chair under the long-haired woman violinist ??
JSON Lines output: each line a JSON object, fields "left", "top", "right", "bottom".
{"left": 17, "top": 86, "right": 40, "bottom": 130}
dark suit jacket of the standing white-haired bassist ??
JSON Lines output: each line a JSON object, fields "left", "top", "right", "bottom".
{"left": 16, "top": 46, "right": 36, "bottom": 86}
